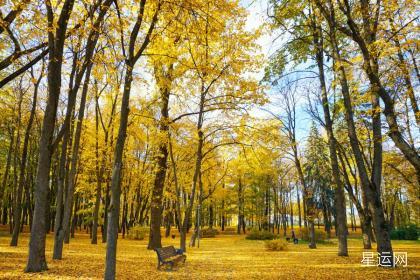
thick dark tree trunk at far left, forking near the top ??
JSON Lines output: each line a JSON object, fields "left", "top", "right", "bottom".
{"left": 25, "top": 0, "right": 74, "bottom": 272}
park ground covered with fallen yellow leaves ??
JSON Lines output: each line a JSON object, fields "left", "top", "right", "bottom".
{"left": 0, "top": 231, "right": 420, "bottom": 280}
